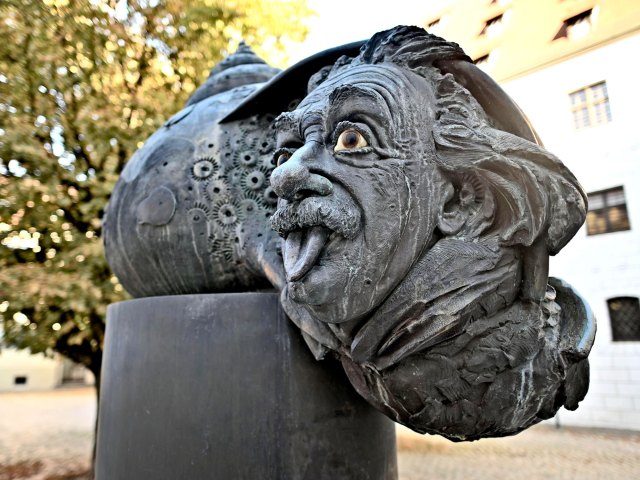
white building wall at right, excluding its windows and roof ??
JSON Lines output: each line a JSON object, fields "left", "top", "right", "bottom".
{"left": 502, "top": 35, "right": 640, "bottom": 430}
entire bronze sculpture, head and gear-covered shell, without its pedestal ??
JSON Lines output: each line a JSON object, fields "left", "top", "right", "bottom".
{"left": 105, "top": 27, "right": 595, "bottom": 441}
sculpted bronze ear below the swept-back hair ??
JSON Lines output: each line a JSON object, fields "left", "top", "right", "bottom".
{"left": 438, "top": 175, "right": 494, "bottom": 237}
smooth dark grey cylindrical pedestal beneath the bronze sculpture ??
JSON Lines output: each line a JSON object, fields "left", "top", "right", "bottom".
{"left": 96, "top": 293, "right": 397, "bottom": 480}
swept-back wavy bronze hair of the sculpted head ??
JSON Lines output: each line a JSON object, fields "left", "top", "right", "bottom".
{"left": 309, "top": 26, "right": 587, "bottom": 262}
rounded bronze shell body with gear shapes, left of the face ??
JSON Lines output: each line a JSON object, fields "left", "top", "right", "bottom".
{"left": 104, "top": 45, "right": 281, "bottom": 297}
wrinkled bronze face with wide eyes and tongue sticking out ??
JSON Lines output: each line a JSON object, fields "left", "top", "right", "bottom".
{"left": 271, "top": 64, "right": 446, "bottom": 323}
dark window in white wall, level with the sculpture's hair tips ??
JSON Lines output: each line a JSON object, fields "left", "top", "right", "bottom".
{"left": 587, "top": 187, "right": 631, "bottom": 235}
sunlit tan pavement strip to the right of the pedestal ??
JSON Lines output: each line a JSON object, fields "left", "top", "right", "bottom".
{"left": 398, "top": 425, "right": 640, "bottom": 480}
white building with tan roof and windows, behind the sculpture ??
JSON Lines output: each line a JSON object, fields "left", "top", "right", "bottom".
{"left": 425, "top": 0, "right": 640, "bottom": 430}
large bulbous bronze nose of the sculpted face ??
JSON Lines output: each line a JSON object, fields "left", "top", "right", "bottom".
{"left": 271, "top": 143, "right": 333, "bottom": 200}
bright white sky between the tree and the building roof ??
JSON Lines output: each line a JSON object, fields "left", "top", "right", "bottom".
{"left": 288, "top": 0, "right": 450, "bottom": 64}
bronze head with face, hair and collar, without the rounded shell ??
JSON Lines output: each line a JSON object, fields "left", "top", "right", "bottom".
{"left": 271, "top": 27, "right": 593, "bottom": 439}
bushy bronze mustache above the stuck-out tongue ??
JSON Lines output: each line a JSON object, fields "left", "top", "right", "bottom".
{"left": 271, "top": 197, "right": 361, "bottom": 240}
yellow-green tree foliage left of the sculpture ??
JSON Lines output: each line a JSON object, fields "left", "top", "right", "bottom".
{"left": 0, "top": 0, "right": 309, "bottom": 373}
